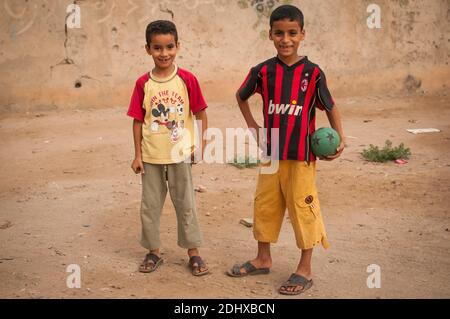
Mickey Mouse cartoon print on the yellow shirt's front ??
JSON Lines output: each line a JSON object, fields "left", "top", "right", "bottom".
{"left": 150, "top": 97, "right": 184, "bottom": 143}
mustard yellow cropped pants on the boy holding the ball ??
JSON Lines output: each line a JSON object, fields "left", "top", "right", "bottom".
{"left": 253, "top": 160, "right": 329, "bottom": 249}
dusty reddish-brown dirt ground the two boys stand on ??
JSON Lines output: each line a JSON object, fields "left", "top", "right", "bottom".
{"left": 0, "top": 93, "right": 450, "bottom": 298}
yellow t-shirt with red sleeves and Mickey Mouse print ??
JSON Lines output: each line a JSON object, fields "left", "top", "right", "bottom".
{"left": 128, "top": 66, "right": 207, "bottom": 164}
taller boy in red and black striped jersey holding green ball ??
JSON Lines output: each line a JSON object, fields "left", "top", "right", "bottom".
{"left": 228, "top": 5, "right": 344, "bottom": 295}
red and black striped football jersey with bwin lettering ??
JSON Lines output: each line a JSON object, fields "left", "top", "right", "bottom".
{"left": 239, "top": 57, "right": 334, "bottom": 162}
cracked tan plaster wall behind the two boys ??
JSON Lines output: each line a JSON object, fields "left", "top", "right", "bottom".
{"left": 0, "top": 0, "right": 450, "bottom": 112}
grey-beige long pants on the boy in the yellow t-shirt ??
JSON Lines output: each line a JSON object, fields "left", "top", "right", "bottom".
{"left": 141, "top": 163, "right": 203, "bottom": 250}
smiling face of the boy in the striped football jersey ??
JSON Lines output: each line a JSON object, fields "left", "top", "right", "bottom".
{"left": 269, "top": 19, "right": 305, "bottom": 58}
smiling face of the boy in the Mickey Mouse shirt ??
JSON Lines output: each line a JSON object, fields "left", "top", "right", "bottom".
{"left": 145, "top": 33, "right": 179, "bottom": 69}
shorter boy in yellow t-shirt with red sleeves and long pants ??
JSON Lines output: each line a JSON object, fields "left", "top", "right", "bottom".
{"left": 127, "top": 20, "right": 209, "bottom": 276}
